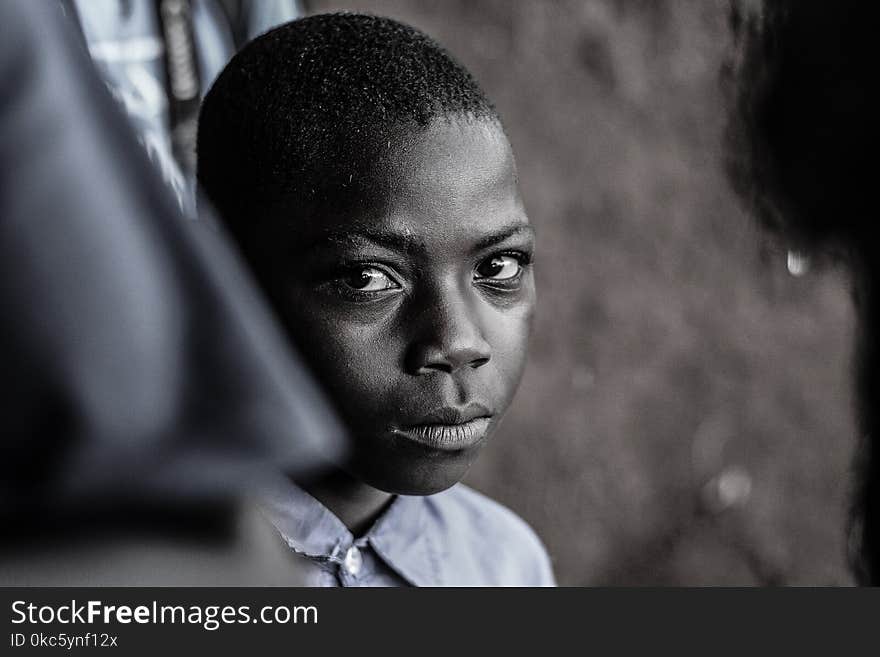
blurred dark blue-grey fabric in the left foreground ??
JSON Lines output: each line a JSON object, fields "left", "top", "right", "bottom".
{"left": 0, "top": 1, "right": 343, "bottom": 584}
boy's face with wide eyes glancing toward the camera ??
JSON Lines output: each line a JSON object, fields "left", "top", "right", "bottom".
{"left": 282, "top": 119, "right": 535, "bottom": 495}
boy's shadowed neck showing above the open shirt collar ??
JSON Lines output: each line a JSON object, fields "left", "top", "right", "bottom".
{"left": 300, "top": 470, "right": 394, "bottom": 536}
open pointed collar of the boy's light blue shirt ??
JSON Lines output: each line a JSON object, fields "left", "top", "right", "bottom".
{"left": 261, "top": 478, "right": 442, "bottom": 586}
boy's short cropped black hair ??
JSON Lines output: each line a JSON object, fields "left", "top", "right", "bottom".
{"left": 198, "top": 13, "right": 500, "bottom": 233}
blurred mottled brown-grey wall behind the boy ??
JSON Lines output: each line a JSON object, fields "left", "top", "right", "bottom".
{"left": 309, "top": 0, "right": 854, "bottom": 585}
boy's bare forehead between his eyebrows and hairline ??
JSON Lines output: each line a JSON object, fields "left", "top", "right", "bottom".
{"left": 288, "top": 118, "right": 528, "bottom": 248}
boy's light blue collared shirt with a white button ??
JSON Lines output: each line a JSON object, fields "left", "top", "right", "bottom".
{"left": 262, "top": 481, "right": 555, "bottom": 586}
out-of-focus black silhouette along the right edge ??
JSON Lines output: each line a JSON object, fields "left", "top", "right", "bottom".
{"left": 722, "top": 0, "right": 880, "bottom": 584}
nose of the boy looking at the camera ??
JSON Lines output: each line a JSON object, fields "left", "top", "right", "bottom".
{"left": 406, "top": 304, "right": 491, "bottom": 374}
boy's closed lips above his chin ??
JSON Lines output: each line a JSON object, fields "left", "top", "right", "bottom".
{"left": 392, "top": 404, "right": 493, "bottom": 451}
